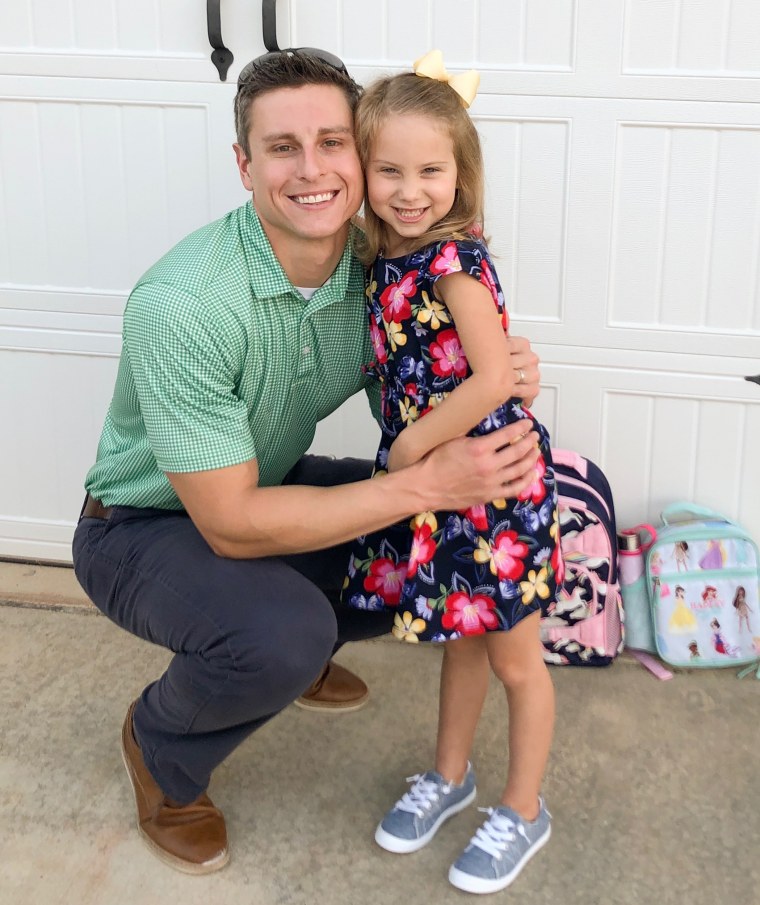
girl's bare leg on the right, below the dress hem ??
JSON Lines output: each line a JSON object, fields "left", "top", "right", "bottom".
{"left": 486, "top": 612, "right": 554, "bottom": 821}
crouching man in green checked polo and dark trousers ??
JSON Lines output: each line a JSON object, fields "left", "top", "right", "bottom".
{"left": 74, "top": 51, "right": 538, "bottom": 874}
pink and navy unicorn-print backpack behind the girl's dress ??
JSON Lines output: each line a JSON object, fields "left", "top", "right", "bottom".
{"left": 541, "top": 449, "right": 623, "bottom": 666}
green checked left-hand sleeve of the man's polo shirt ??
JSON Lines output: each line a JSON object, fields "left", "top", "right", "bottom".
{"left": 124, "top": 283, "right": 256, "bottom": 472}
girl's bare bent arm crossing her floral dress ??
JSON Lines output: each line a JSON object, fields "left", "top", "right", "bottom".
{"left": 388, "top": 273, "right": 514, "bottom": 471}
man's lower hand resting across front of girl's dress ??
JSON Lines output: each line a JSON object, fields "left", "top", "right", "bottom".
{"left": 412, "top": 418, "right": 539, "bottom": 509}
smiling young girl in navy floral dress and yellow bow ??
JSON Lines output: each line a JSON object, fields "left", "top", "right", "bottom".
{"left": 343, "top": 51, "right": 560, "bottom": 893}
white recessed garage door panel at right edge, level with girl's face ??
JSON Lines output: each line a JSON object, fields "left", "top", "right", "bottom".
{"left": 610, "top": 123, "right": 760, "bottom": 333}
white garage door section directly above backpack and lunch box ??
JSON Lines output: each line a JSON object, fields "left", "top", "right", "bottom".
{"left": 546, "top": 366, "right": 760, "bottom": 534}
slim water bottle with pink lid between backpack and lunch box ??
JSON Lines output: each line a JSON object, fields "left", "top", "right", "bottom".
{"left": 617, "top": 525, "right": 657, "bottom": 653}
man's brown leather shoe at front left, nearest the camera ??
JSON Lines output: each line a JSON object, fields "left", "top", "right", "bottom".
{"left": 121, "top": 702, "right": 230, "bottom": 874}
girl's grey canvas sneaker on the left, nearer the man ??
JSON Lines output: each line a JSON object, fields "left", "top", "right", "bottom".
{"left": 375, "top": 763, "right": 477, "bottom": 854}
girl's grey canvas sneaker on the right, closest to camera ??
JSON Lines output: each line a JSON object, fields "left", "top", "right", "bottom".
{"left": 449, "top": 798, "right": 552, "bottom": 893}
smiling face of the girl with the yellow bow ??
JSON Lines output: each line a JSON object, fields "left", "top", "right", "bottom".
{"left": 366, "top": 114, "right": 457, "bottom": 257}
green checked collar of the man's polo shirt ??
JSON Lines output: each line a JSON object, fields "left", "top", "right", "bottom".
{"left": 241, "top": 201, "right": 364, "bottom": 313}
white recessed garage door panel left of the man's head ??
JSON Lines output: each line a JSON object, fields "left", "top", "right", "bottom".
{"left": 0, "top": 92, "right": 214, "bottom": 292}
